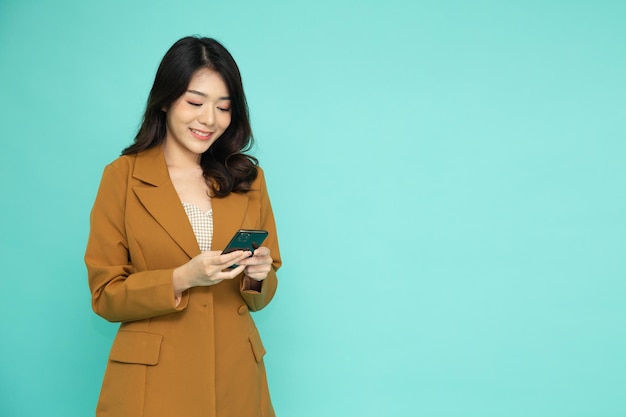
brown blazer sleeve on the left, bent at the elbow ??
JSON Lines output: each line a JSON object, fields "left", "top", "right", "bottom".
{"left": 85, "top": 163, "right": 188, "bottom": 322}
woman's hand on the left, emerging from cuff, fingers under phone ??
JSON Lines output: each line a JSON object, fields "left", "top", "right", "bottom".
{"left": 172, "top": 251, "right": 252, "bottom": 298}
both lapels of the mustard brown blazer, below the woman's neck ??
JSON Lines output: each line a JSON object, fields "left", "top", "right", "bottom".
{"left": 133, "top": 146, "right": 248, "bottom": 258}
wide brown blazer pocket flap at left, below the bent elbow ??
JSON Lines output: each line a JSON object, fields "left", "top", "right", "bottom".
{"left": 109, "top": 330, "right": 163, "bottom": 365}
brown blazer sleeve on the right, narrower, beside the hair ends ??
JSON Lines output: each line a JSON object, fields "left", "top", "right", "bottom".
{"left": 241, "top": 168, "right": 282, "bottom": 311}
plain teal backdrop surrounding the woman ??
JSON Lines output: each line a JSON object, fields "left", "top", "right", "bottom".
{"left": 0, "top": 0, "right": 626, "bottom": 417}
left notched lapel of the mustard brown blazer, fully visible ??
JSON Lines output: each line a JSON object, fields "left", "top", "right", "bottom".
{"left": 133, "top": 146, "right": 200, "bottom": 258}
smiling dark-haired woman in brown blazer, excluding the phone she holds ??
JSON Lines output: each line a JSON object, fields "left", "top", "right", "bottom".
{"left": 85, "top": 37, "right": 281, "bottom": 417}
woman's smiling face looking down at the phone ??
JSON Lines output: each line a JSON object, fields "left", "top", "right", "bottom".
{"left": 164, "top": 68, "right": 231, "bottom": 158}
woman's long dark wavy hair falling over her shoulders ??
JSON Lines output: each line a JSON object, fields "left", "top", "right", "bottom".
{"left": 122, "top": 36, "right": 258, "bottom": 197}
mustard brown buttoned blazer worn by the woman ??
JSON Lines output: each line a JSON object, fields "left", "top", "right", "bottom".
{"left": 85, "top": 146, "right": 281, "bottom": 417}
